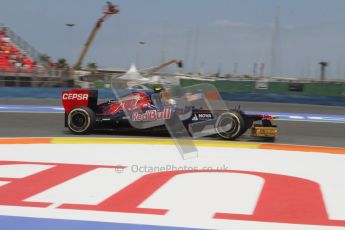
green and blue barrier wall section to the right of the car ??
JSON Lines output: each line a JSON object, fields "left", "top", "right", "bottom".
{"left": 180, "top": 79, "right": 345, "bottom": 106}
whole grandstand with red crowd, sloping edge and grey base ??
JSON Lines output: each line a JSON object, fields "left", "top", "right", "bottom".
{"left": 0, "top": 24, "right": 71, "bottom": 87}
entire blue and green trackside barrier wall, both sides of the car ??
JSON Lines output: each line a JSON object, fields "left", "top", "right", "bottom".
{"left": 0, "top": 79, "right": 345, "bottom": 106}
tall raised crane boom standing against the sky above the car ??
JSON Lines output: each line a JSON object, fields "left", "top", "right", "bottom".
{"left": 73, "top": 2, "right": 119, "bottom": 70}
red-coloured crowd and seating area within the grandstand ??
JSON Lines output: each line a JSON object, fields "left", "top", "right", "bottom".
{"left": 0, "top": 28, "right": 35, "bottom": 73}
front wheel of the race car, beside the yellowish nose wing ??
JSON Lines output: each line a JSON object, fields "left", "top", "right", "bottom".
{"left": 215, "top": 111, "right": 246, "bottom": 140}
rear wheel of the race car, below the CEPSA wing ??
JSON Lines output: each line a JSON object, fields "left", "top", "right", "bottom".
{"left": 67, "top": 106, "right": 96, "bottom": 134}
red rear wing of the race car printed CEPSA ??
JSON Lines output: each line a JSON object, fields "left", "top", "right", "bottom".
{"left": 61, "top": 89, "right": 98, "bottom": 113}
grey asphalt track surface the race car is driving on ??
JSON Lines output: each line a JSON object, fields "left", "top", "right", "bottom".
{"left": 0, "top": 99, "right": 345, "bottom": 147}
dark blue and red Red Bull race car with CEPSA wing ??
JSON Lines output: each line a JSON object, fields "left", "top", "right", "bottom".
{"left": 62, "top": 89, "right": 277, "bottom": 140}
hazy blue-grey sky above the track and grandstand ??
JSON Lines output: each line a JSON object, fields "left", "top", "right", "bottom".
{"left": 0, "top": 0, "right": 345, "bottom": 79}
